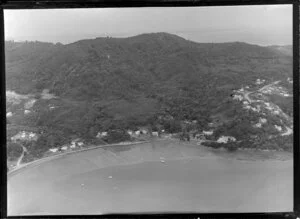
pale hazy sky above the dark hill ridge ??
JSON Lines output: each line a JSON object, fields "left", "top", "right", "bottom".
{"left": 4, "top": 5, "right": 293, "bottom": 46}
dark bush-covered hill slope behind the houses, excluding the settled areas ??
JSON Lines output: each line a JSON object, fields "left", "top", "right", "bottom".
{"left": 5, "top": 33, "right": 292, "bottom": 162}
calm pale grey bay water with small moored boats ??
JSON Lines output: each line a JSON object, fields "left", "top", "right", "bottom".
{"left": 8, "top": 141, "right": 293, "bottom": 215}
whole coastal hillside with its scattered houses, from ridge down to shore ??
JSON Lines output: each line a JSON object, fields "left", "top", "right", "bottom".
{"left": 5, "top": 33, "right": 293, "bottom": 166}
